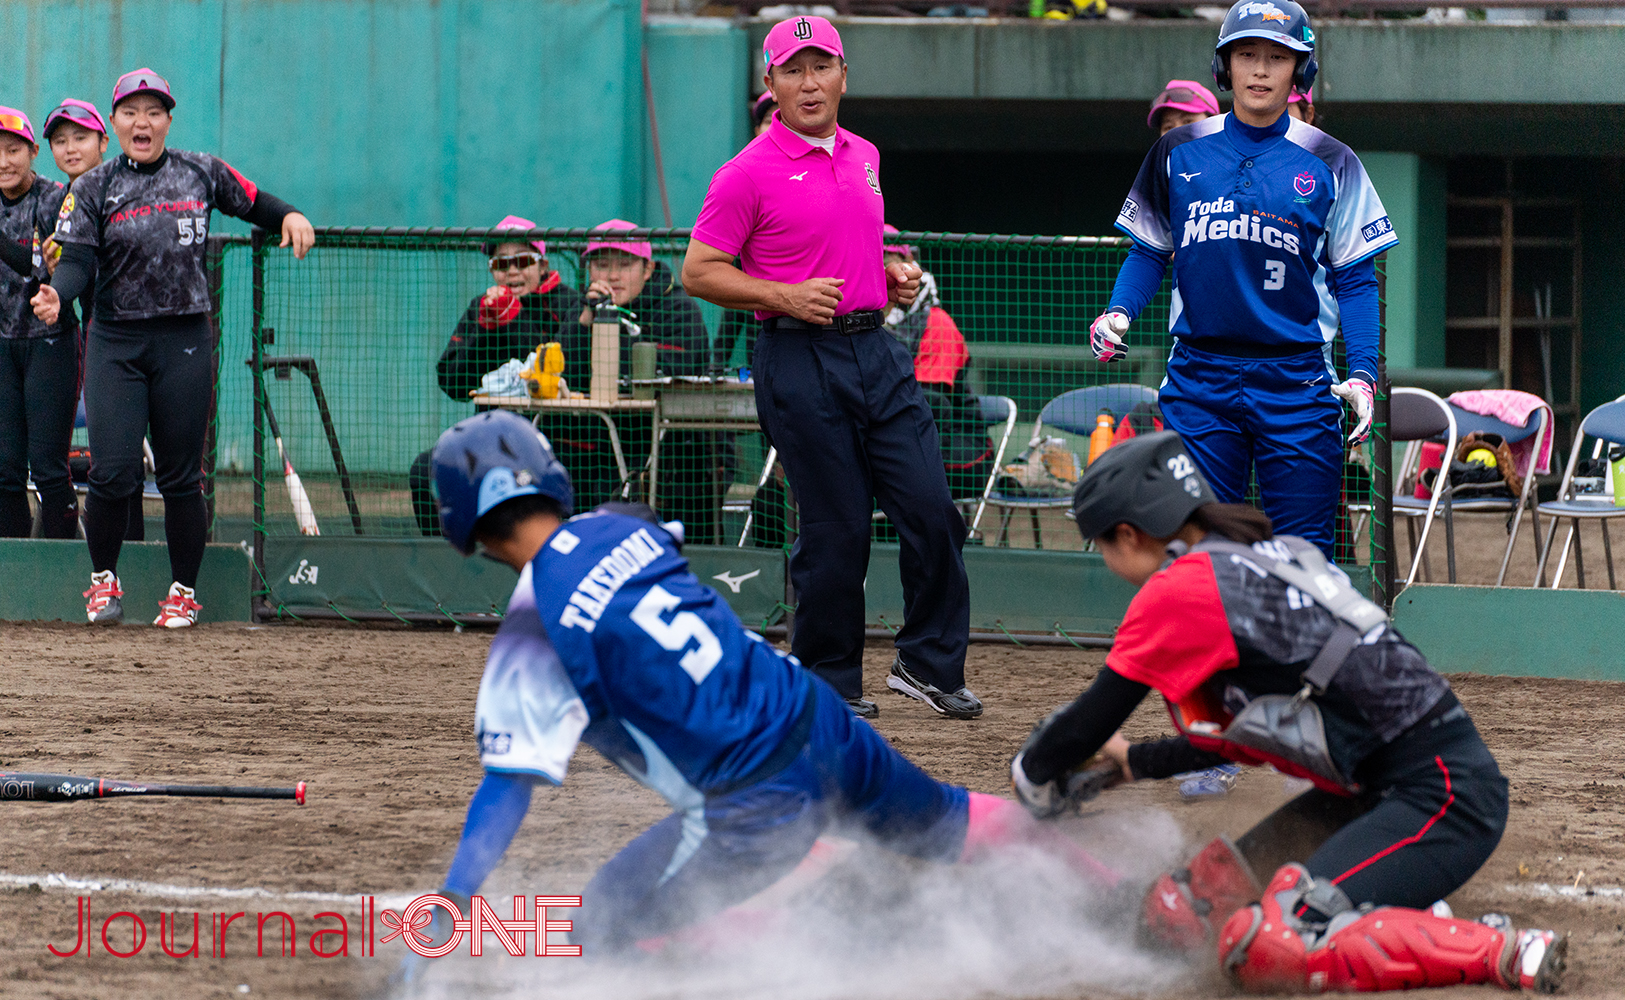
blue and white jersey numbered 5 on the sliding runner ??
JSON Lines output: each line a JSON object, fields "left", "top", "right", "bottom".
{"left": 475, "top": 512, "right": 813, "bottom": 808}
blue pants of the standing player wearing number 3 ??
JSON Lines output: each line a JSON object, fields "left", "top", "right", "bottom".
{"left": 1159, "top": 341, "right": 1342, "bottom": 559}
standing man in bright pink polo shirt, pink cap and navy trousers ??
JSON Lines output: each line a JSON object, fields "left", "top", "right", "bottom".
{"left": 683, "top": 16, "right": 982, "bottom": 719}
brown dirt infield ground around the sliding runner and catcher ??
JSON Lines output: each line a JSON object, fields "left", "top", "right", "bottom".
{"left": 0, "top": 624, "right": 1625, "bottom": 1000}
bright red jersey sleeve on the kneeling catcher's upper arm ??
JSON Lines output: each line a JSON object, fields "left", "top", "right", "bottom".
{"left": 1107, "top": 553, "right": 1242, "bottom": 701}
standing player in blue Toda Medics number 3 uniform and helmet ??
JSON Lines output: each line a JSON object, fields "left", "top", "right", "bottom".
{"left": 1089, "top": 0, "right": 1398, "bottom": 556}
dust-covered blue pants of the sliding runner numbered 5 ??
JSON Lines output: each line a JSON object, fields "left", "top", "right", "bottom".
{"left": 570, "top": 681, "right": 970, "bottom": 956}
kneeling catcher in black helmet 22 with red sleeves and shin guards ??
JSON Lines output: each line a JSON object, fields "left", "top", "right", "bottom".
{"left": 1011, "top": 431, "right": 1567, "bottom": 992}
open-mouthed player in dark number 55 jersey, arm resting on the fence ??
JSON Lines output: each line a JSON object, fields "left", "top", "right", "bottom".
{"left": 34, "top": 68, "right": 315, "bottom": 628}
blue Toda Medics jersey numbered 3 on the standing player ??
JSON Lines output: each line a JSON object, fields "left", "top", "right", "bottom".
{"left": 1116, "top": 114, "right": 1398, "bottom": 372}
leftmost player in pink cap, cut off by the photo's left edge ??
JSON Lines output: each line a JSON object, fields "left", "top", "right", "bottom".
{"left": 0, "top": 107, "right": 80, "bottom": 538}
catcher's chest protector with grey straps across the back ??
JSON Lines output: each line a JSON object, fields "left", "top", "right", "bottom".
{"left": 1168, "top": 535, "right": 1388, "bottom": 795}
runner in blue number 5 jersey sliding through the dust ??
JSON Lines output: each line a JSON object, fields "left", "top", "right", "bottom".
{"left": 386, "top": 411, "right": 1113, "bottom": 980}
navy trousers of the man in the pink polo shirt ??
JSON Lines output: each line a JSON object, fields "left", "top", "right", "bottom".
{"left": 752, "top": 327, "right": 970, "bottom": 698}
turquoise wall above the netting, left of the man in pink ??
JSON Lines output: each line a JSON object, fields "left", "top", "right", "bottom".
{"left": 0, "top": 0, "right": 748, "bottom": 229}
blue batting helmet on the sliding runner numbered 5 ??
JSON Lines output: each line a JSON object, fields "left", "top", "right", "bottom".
{"left": 434, "top": 410, "right": 575, "bottom": 556}
